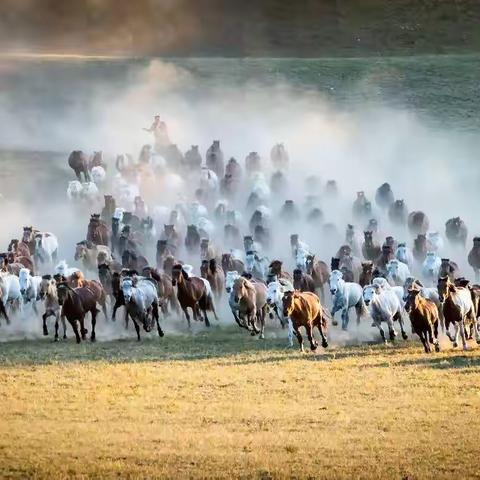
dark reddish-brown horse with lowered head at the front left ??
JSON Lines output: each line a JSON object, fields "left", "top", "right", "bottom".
{"left": 57, "top": 282, "right": 98, "bottom": 343}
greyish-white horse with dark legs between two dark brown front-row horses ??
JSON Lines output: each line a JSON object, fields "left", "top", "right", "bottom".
{"left": 122, "top": 277, "right": 164, "bottom": 341}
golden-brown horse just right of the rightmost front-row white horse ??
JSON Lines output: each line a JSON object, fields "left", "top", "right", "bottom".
{"left": 405, "top": 288, "right": 440, "bottom": 353}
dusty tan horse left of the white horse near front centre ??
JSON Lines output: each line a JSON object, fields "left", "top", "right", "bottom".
{"left": 232, "top": 277, "right": 267, "bottom": 338}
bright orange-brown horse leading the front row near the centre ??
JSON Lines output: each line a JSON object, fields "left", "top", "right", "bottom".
{"left": 283, "top": 292, "right": 328, "bottom": 352}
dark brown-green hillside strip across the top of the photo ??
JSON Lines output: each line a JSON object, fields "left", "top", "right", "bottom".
{"left": 0, "top": 0, "right": 480, "bottom": 57}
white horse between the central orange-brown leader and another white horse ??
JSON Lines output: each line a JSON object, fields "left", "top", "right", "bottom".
{"left": 328, "top": 270, "right": 365, "bottom": 330}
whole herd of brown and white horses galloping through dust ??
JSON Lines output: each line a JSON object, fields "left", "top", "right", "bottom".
{"left": 0, "top": 137, "right": 480, "bottom": 352}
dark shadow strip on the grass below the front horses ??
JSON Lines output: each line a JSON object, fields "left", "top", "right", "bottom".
{"left": 0, "top": 327, "right": 404, "bottom": 367}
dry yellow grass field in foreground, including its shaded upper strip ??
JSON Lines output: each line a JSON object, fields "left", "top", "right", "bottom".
{"left": 0, "top": 329, "right": 480, "bottom": 479}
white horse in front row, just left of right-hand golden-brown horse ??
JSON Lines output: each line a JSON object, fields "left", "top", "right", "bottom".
{"left": 363, "top": 285, "right": 407, "bottom": 342}
